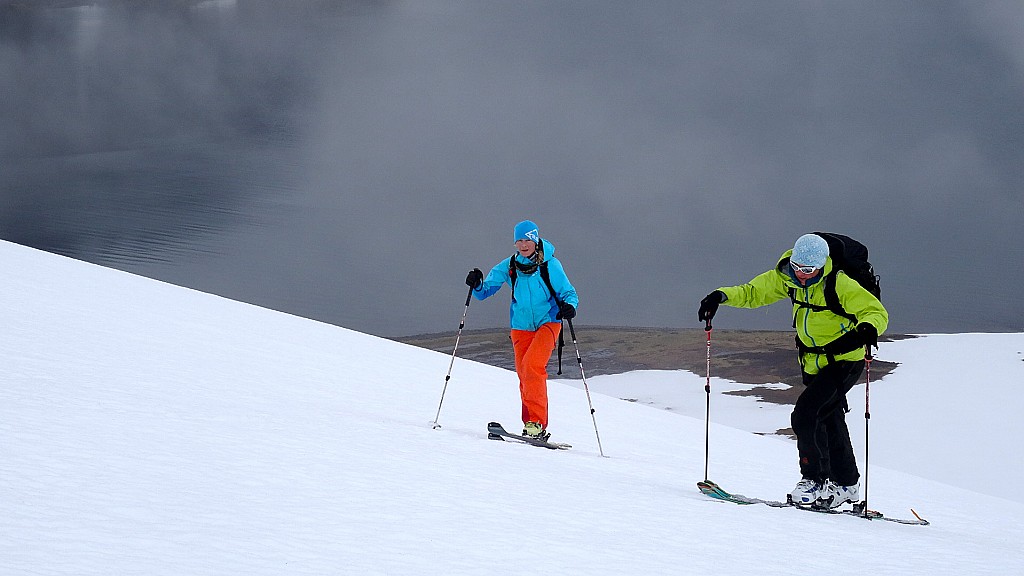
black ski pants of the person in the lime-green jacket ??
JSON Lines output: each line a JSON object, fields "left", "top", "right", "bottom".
{"left": 792, "top": 360, "right": 864, "bottom": 486}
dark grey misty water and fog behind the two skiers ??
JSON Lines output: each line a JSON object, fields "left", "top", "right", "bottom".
{"left": 0, "top": 0, "right": 1024, "bottom": 336}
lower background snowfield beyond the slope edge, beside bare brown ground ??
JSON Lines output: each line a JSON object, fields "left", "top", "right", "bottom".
{"left": 565, "top": 333, "right": 1024, "bottom": 503}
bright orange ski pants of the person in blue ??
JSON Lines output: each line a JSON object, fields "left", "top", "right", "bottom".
{"left": 512, "top": 322, "right": 562, "bottom": 428}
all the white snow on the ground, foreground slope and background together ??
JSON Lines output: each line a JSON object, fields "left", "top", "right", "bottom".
{"left": 0, "top": 235, "right": 1024, "bottom": 576}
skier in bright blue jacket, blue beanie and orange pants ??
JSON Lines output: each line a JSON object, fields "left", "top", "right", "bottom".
{"left": 466, "top": 220, "right": 580, "bottom": 440}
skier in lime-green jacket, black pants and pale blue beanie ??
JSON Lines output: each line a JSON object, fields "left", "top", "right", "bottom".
{"left": 697, "top": 234, "right": 889, "bottom": 507}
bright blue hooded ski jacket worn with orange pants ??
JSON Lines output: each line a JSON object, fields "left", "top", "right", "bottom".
{"left": 473, "top": 239, "right": 580, "bottom": 331}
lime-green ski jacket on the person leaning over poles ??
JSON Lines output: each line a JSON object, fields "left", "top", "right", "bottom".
{"left": 719, "top": 250, "right": 889, "bottom": 374}
